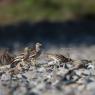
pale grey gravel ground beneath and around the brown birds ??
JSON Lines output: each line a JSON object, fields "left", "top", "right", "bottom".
{"left": 0, "top": 46, "right": 95, "bottom": 95}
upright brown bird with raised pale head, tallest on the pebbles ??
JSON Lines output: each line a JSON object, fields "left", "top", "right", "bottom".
{"left": 29, "top": 43, "right": 42, "bottom": 65}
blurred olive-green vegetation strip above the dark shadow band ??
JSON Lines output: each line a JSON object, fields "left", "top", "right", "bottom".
{"left": 0, "top": 0, "right": 95, "bottom": 24}
